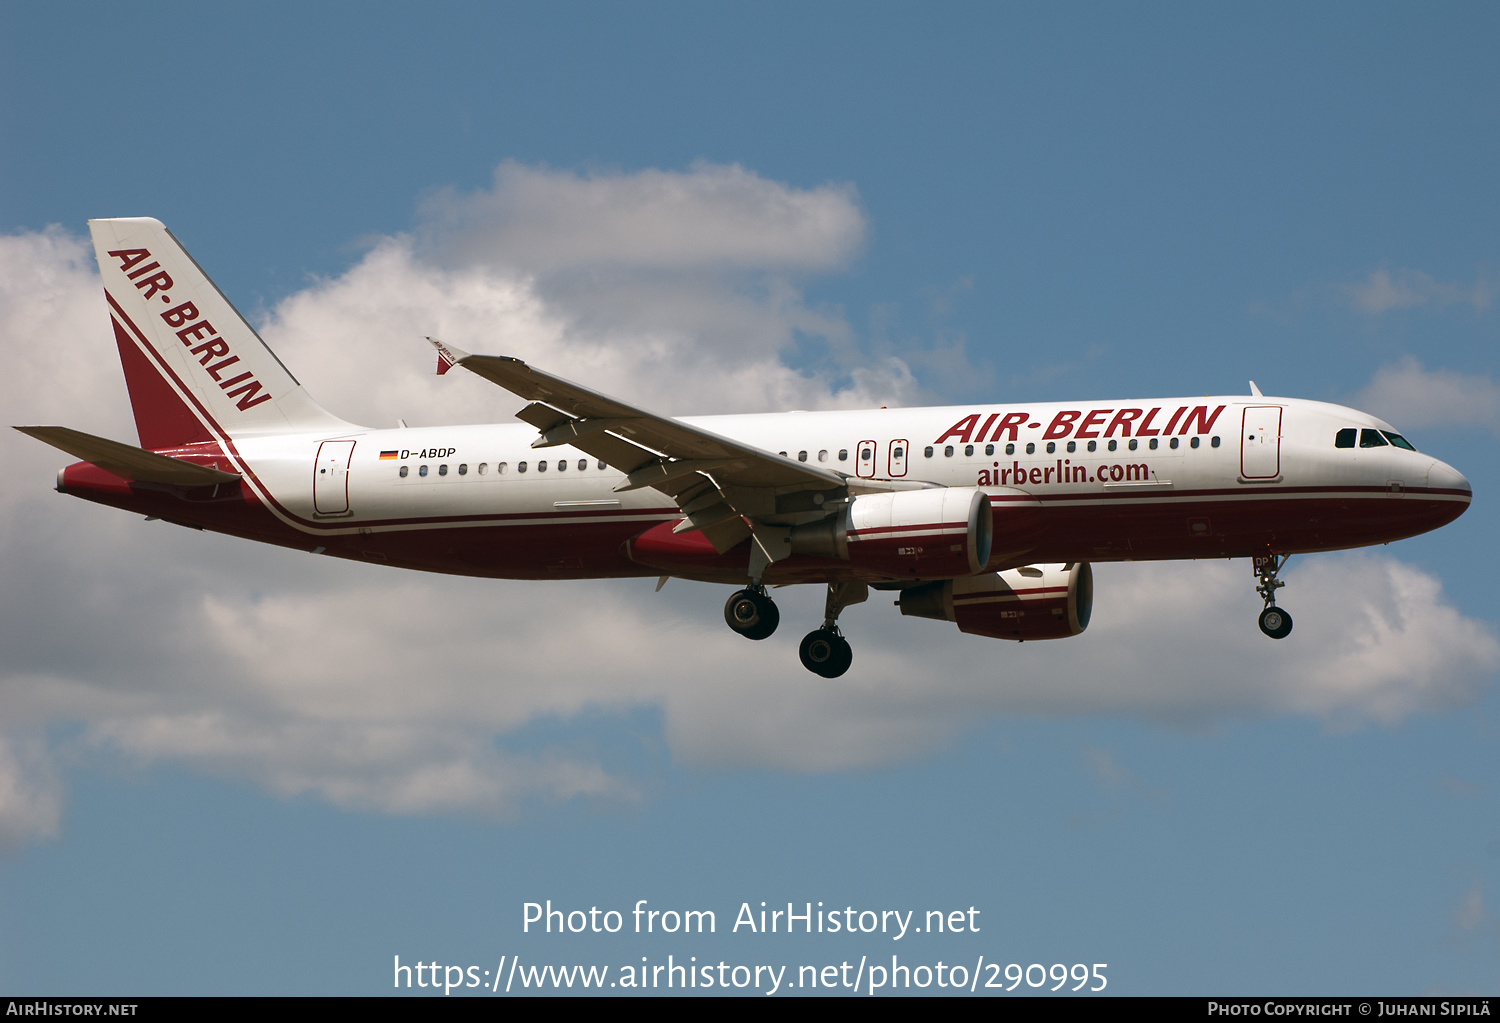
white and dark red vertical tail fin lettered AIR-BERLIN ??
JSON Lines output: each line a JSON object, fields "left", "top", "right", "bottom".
{"left": 89, "top": 218, "right": 350, "bottom": 449}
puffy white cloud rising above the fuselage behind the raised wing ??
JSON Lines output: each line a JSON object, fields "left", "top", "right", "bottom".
{"left": 263, "top": 164, "right": 923, "bottom": 425}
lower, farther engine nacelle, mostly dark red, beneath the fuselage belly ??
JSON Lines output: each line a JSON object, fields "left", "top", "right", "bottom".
{"left": 897, "top": 561, "right": 1094, "bottom": 641}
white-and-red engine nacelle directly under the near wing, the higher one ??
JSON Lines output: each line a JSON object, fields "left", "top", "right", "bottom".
{"left": 791, "top": 486, "right": 995, "bottom": 579}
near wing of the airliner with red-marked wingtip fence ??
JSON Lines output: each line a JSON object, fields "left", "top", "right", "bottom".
{"left": 428, "top": 338, "right": 876, "bottom": 567}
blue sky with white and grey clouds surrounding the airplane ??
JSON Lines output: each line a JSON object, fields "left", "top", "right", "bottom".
{"left": 0, "top": 2, "right": 1500, "bottom": 998}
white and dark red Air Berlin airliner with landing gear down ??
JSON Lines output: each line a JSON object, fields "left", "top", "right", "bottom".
{"left": 15, "top": 218, "right": 1472, "bottom": 678}
